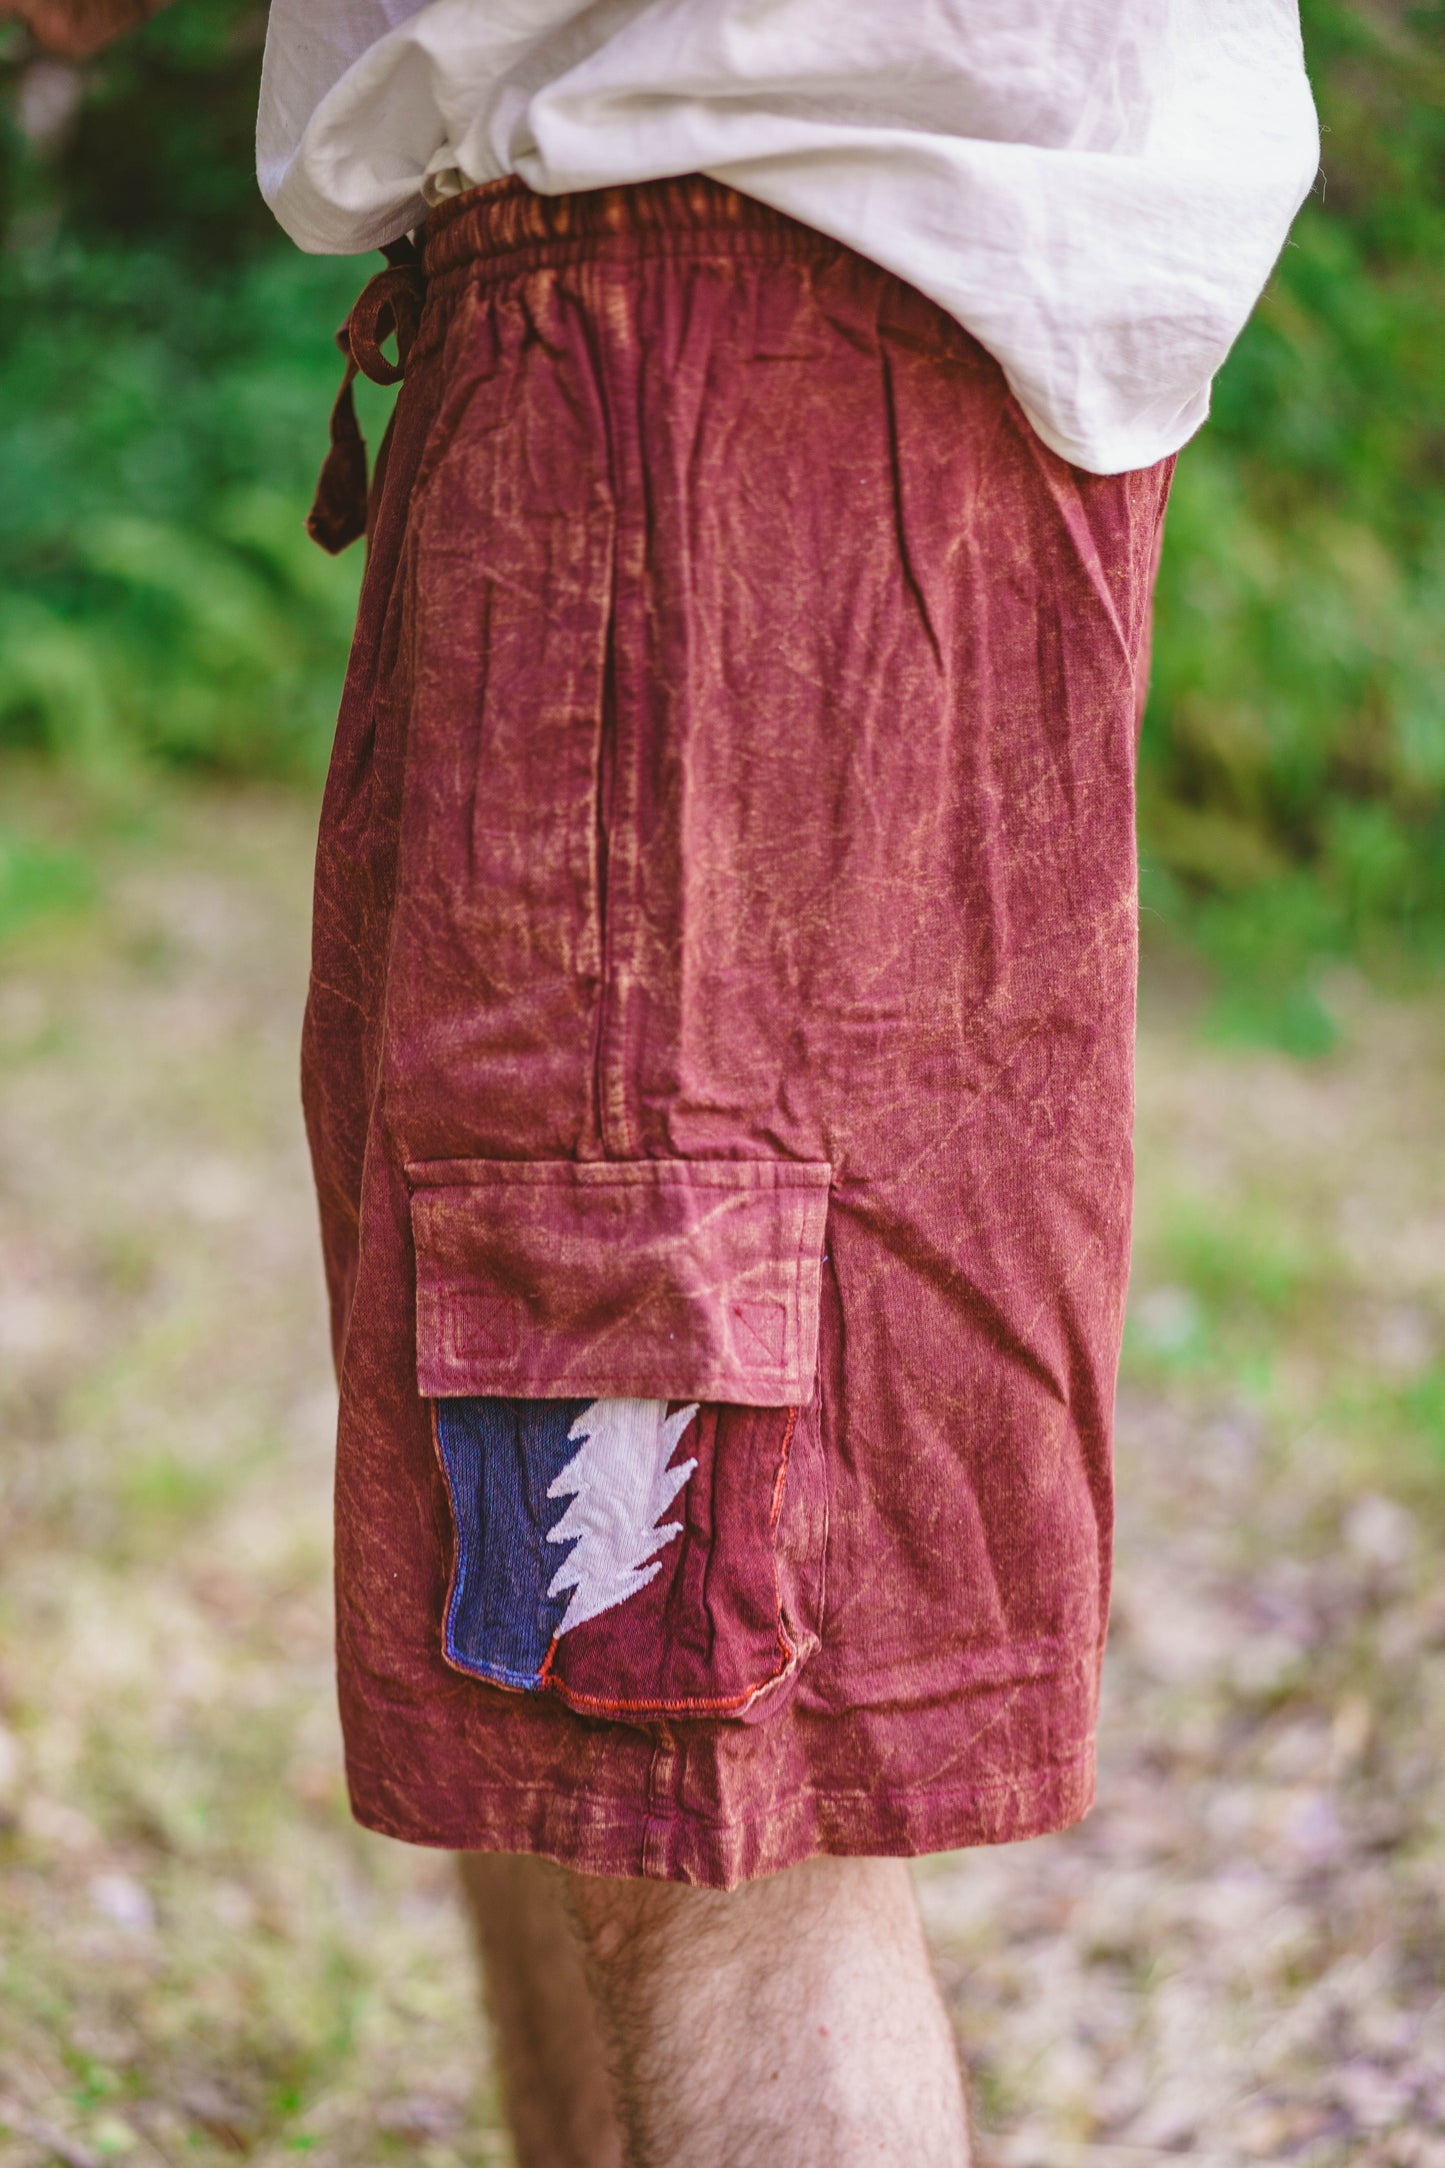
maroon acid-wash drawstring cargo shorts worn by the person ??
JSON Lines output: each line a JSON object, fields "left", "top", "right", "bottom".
{"left": 303, "top": 178, "right": 1170, "bottom": 1888}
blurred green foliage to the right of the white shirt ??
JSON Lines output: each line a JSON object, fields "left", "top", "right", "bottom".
{"left": 1140, "top": 0, "right": 1445, "bottom": 1005}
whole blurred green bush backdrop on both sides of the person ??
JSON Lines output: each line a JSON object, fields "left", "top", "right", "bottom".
{"left": 0, "top": 0, "right": 1445, "bottom": 992}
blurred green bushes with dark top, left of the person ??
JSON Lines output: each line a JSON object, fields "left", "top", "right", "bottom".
{"left": 0, "top": 0, "right": 361, "bottom": 783}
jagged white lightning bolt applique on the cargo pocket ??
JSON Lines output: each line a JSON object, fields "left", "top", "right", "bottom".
{"left": 546, "top": 1401, "right": 698, "bottom": 1635}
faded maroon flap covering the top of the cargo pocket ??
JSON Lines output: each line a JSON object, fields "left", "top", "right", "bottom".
{"left": 407, "top": 1160, "right": 832, "bottom": 1407}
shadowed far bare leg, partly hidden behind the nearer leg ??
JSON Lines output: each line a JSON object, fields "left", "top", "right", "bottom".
{"left": 457, "top": 1851, "right": 622, "bottom": 2168}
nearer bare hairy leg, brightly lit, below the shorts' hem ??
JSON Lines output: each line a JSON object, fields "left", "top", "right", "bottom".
{"left": 565, "top": 1860, "right": 968, "bottom": 2168}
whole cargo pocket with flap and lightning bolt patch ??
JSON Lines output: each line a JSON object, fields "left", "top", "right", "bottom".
{"left": 407, "top": 1160, "right": 830, "bottom": 1721}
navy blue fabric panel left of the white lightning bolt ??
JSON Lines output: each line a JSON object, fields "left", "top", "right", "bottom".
{"left": 435, "top": 1401, "right": 591, "bottom": 1687}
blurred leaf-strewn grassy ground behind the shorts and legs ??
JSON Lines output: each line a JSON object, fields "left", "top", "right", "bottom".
{"left": 0, "top": 793, "right": 1445, "bottom": 2168}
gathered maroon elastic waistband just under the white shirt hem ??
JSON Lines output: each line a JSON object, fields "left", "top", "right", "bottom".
{"left": 422, "top": 173, "right": 843, "bottom": 280}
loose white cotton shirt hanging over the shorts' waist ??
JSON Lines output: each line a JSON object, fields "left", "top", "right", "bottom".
{"left": 258, "top": 0, "right": 1319, "bottom": 473}
